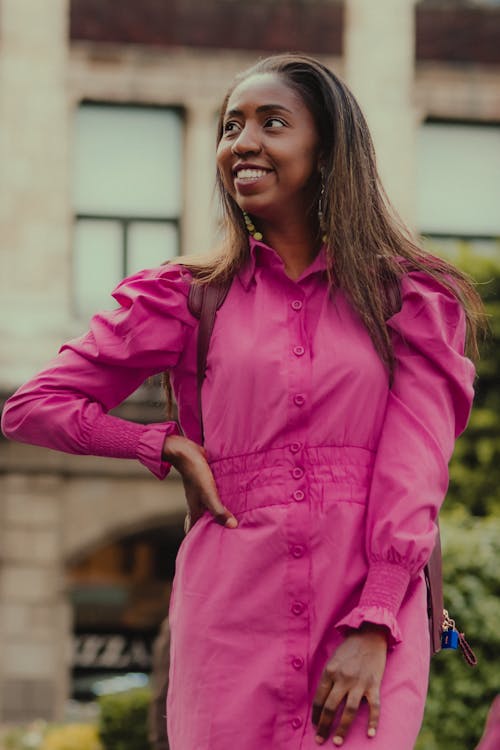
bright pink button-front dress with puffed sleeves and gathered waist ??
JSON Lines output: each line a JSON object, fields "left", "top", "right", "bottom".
{"left": 3, "top": 240, "right": 474, "bottom": 750}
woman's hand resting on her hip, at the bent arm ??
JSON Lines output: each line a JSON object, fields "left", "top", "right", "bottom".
{"left": 163, "top": 435, "right": 238, "bottom": 533}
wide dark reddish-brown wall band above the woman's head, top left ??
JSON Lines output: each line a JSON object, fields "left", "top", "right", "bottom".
{"left": 70, "top": 0, "right": 342, "bottom": 55}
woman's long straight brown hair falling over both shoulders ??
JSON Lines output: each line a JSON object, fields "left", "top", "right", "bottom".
{"left": 166, "top": 54, "right": 486, "bottom": 414}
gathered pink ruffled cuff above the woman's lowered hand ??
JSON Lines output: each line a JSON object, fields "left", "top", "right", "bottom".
{"left": 336, "top": 561, "right": 410, "bottom": 646}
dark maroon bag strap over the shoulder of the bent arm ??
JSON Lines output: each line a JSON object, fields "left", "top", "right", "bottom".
{"left": 188, "top": 279, "right": 231, "bottom": 445}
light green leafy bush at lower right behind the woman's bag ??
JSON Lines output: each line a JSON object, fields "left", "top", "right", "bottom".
{"left": 416, "top": 510, "right": 500, "bottom": 750}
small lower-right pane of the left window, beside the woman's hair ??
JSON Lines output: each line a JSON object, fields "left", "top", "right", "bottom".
{"left": 127, "top": 221, "right": 179, "bottom": 274}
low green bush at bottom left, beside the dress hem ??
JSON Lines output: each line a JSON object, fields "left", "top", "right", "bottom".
{"left": 99, "top": 688, "right": 151, "bottom": 750}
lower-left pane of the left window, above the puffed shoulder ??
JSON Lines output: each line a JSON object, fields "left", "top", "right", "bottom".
{"left": 74, "top": 220, "right": 123, "bottom": 318}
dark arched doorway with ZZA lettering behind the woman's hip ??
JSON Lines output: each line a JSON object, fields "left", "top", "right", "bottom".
{"left": 66, "top": 516, "right": 184, "bottom": 701}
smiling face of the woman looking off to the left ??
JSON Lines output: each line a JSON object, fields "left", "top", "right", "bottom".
{"left": 217, "top": 73, "right": 319, "bottom": 226}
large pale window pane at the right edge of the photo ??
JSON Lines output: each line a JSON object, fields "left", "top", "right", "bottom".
{"left": 417, "top": 123, "right": 500, "bottom": 235}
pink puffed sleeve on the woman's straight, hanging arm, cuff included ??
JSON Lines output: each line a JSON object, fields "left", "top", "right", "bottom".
{"left": 337, "top": 272, "right": 475, "bottom": 644}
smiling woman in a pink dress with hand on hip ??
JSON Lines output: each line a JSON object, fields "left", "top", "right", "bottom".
{"left": 3, "top": 55, "right": 481, "bottom": 750}
